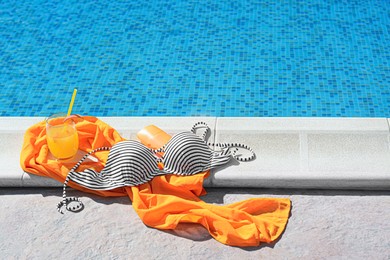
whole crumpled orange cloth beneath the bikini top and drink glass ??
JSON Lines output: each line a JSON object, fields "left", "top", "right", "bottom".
{"left": 20, "top": 117, "right": 291, "bottom": 247}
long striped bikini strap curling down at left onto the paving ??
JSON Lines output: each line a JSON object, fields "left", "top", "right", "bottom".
{"left": 57, "top": 147, "right": 111, "bottom": 214}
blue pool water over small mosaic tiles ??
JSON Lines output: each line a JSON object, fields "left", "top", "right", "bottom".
{"left": 0, "top": 0, "right": 390, "bottom": 117}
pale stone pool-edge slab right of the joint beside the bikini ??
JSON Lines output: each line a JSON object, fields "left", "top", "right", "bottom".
{"left": 211, "top": 118, "right": 390, "bottom": 189}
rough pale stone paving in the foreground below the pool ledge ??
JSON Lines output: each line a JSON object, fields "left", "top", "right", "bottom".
{"left": 0, "top": 188, "right": 390, "bottom": 259}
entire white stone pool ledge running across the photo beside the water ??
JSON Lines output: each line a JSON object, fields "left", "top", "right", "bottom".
{"left": 0, "top": 117, "right": 390, "bottom": 190}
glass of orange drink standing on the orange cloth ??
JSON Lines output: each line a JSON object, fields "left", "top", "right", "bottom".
{"left": 46, "top": 114, "right": 79, "bottom": 160}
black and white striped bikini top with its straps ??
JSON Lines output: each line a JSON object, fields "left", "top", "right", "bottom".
{"left": 57, "top": 122, "right": 255, "bottom": 213}
